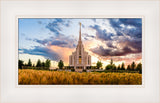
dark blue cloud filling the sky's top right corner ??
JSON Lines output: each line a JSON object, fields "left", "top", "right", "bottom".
{"left": 109, "top": 18, "right": 142, "bottom": 38}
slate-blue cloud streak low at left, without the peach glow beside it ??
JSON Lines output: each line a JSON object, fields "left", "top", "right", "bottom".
{"left": 19, "top": 46, "right": 61, "bottom": 61}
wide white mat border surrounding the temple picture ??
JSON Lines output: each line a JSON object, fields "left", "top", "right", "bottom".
{"left": 0, "top": 0, "right": 160, "bottom": 103}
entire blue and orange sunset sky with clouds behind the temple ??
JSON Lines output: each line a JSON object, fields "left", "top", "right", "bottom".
{"left": 18, "top": 18, "right": 142, "bottom": 68}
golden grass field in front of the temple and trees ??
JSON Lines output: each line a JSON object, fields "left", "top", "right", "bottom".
{"left": 18, "top": 69, "right": 142, "bottom": 85}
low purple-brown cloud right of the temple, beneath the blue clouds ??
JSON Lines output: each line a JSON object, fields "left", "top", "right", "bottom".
{"left": 90, "top": 38, "right": 142, "bottom": 56}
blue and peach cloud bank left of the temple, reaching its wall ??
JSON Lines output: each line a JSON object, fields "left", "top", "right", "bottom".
{"left": 19, "top": 45, "right": 75, "bottom": 63}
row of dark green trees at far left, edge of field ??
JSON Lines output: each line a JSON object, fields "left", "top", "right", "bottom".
{"left": 18, "top": 59, "right": 51, "bottom": 70}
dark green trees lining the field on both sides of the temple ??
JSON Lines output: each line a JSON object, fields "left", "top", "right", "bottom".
{"left": 18, "top": 59, "right": 142, "bottom": 73}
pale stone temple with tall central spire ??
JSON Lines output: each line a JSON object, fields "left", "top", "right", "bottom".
{"left": 69, "top": 23, "right": 91, "bottom": 71}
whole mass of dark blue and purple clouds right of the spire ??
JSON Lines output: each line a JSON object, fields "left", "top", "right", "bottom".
{"left": 90, "top": 18, "right": 142, "bottom": 56}
